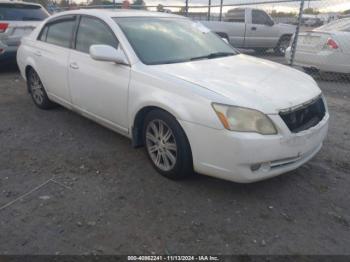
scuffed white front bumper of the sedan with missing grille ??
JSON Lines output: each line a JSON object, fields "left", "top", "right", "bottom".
{"left": 180, "top": 113, "right": 329, "bottom": 183}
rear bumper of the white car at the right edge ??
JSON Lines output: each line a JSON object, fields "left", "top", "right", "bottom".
{"left": 286, "top": 48, "right": 350, "bottom": 74}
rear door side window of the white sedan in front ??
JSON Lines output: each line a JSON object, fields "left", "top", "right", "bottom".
{"left": 44, "top": 19, "right": 75, "bottom": 48}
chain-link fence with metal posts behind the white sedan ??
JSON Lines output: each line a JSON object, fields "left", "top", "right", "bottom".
{"left": 53, "top": 0, "right": 350, "bottom": 83}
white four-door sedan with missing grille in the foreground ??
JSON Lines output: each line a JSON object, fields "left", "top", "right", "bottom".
{"left": 17, "top": 10, "right": 329, "bottom": 183}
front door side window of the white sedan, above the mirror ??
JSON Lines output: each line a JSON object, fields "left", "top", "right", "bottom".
{"left": 75, "top": 16, "right": 119, "bottom": 53}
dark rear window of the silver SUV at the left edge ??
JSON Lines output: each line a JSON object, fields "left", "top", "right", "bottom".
{"left": 0, "top": 3, "right": 48, "bottom": 21}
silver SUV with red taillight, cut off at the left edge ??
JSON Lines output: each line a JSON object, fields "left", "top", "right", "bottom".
{"left": 0, "top": 0, "right": 49, "bottom": 63}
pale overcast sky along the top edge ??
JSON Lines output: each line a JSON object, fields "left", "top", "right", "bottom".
{"left": 144, "top": 0, "right": 350, "bottom": 12}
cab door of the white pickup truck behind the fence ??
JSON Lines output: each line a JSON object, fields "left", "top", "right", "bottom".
{"left": 245, "top": 9, "right": 279, "bottom": 48}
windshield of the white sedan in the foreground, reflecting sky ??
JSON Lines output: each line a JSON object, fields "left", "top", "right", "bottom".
{"left": 114, "top": 17, "right": 237, "bottom": 65}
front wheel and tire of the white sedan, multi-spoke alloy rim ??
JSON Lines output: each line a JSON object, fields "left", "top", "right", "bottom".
{"left": 143, "top": 110, "right": 193, "bottom": 180}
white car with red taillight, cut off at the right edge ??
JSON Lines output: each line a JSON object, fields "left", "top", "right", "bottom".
{"left": 286, "top": 18, "right": 350, "bottom": 74}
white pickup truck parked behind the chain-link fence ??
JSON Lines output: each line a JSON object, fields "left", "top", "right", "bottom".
{"left": 201, "top": 8, "right": 296, "bottom": 56}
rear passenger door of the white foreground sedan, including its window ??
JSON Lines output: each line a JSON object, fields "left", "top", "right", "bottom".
{"left": 33, "top": 15, "right": 77, "bottom": 106}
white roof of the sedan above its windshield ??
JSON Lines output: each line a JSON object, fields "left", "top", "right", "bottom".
{"left": 55, "top": 9, "right": 184, "bottom": 18}
